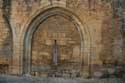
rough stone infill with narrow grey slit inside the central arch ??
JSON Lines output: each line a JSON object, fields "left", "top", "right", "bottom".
{"left": 31, "top": 14, "right": 82, "bottom": 77}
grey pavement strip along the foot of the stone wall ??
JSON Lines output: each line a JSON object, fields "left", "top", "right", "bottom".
{"left": 0, "top": 76, "right": 125, "bottom": 83}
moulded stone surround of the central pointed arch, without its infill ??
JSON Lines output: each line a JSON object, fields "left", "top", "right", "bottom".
{"left": 23, "top": 7, "right": 91, "bottom": 77}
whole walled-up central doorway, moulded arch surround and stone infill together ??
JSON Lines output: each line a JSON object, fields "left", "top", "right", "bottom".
{"left": 23, "top": 7, "right": 91, "bottom": 77}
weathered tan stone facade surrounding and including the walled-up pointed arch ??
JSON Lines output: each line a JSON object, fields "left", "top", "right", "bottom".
{"left": 0, "top": 0, "right": 125, "bottom": 77}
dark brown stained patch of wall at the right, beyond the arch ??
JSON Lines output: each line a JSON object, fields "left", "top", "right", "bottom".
{"left": 100, "top": 11, "right": 122, "bottom": 65}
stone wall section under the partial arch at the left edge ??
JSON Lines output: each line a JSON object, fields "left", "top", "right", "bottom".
{"left": 0, "top": 1, "right": 13, "bottom": 74}
